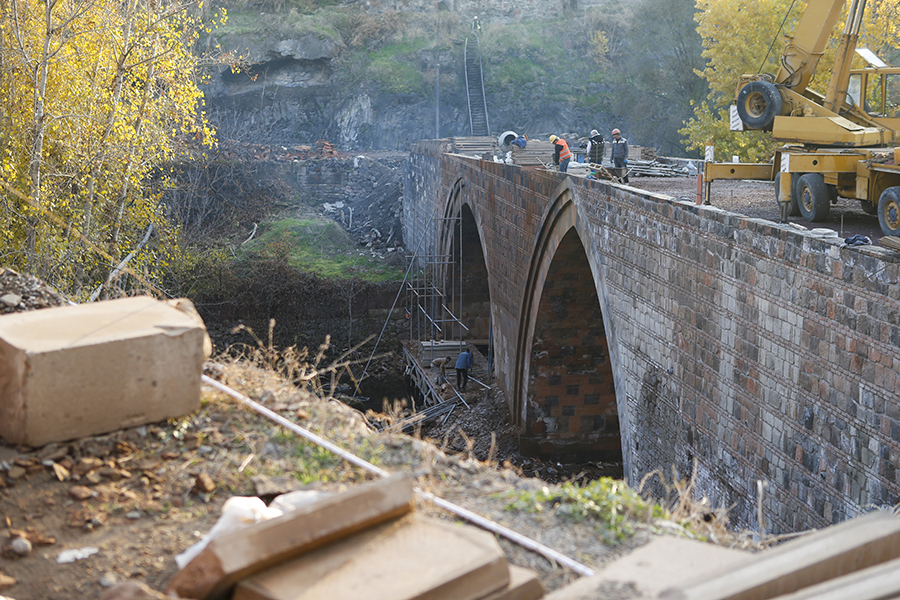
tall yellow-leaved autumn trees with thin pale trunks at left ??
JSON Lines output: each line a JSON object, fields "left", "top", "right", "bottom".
{"left": 0, "top": 0, "right": 224, "bottom": 298}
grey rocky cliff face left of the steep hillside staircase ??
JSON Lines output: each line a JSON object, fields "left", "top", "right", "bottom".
{"left": 206, "top": 21, "right": 467, "bottom": 150}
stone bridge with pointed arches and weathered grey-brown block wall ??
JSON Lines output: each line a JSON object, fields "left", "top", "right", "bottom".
{"left": 403, "top": 140, "right": 900, "bottom": 533}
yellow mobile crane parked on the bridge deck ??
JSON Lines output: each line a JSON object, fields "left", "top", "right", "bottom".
{"left": 704, "top": 0, "right": 900, "bottom": 236}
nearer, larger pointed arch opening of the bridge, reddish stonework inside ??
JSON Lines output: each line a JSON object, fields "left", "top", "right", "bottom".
{"left": 511, "top": 182, "right": 623, "bottom": 462}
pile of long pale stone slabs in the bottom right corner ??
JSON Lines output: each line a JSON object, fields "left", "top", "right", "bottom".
{"left": 547, "top": 511, "right": 900, "bottom": 600}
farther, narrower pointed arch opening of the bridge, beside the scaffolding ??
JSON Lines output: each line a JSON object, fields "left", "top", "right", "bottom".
{"left": 438, "top": 179, "right": 492, "bottom": 355}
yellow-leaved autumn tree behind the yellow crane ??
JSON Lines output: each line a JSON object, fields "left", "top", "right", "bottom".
{"left": 679, "top": 0, "right": 900, "bottom": 162}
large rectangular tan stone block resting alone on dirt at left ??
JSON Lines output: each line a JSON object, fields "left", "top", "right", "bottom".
{"left": 0, "top": 296, "right": 210, "bottom": 446}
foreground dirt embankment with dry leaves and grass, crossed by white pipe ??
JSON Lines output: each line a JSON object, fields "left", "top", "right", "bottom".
{"left": 0, "top": 356, "right": 760, "bottom": 600}
